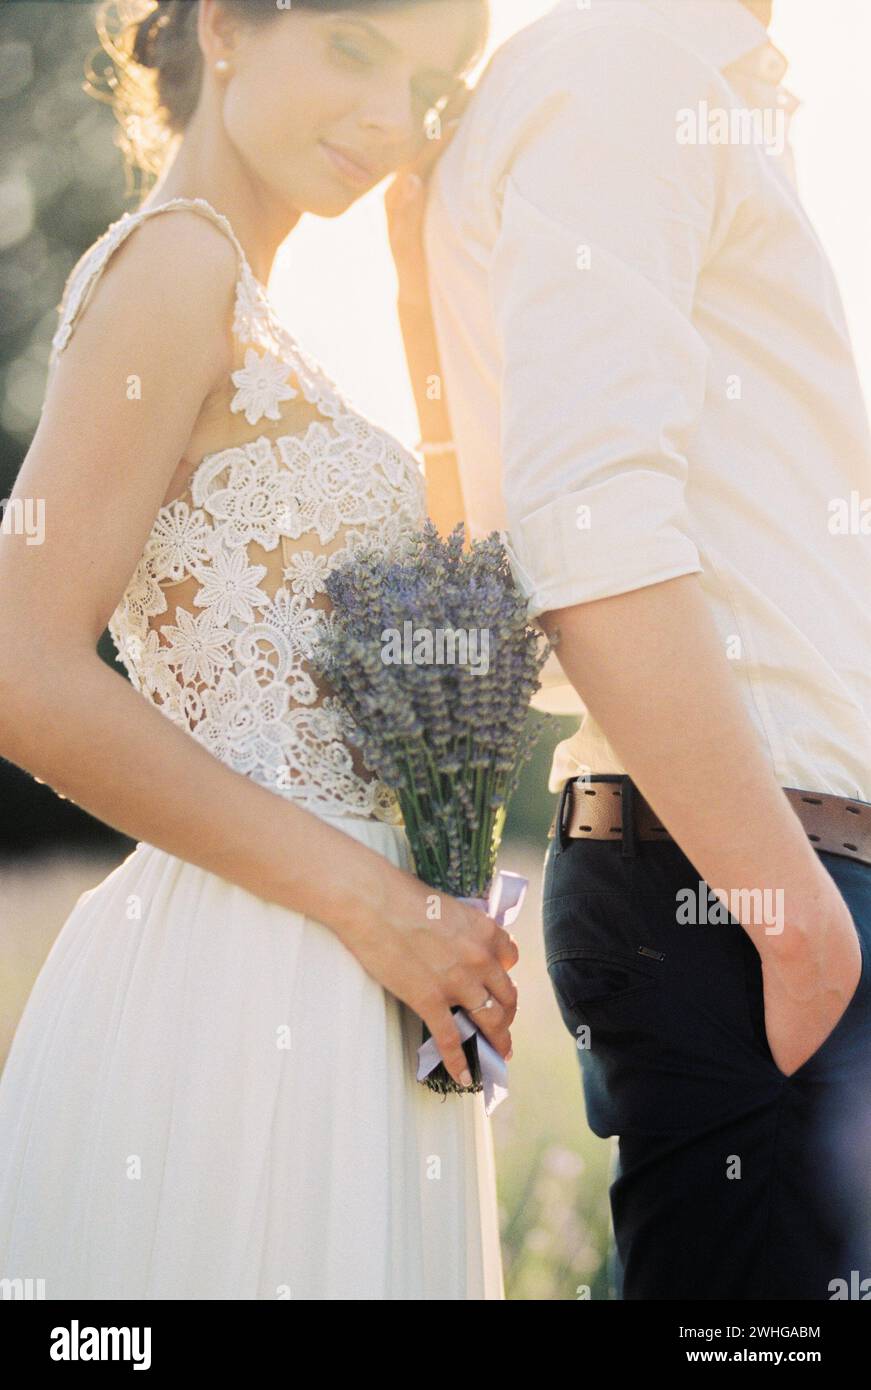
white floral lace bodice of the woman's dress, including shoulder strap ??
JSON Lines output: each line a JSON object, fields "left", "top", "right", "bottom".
{"left": 51, "top": 199, "right": 425, "bottom": 821}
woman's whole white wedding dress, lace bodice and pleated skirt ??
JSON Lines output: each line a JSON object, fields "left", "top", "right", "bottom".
{"left": 0, "top": 199, "right": 503, "bottom": 1300}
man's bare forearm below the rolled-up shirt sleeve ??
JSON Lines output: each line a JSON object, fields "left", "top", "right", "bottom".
{"left": 539, "top": 574, "right": 846, "bottom": 951}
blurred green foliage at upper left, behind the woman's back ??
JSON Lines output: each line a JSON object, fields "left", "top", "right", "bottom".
{"left": 0, "top": 0, "right": 125, "bottom": 496}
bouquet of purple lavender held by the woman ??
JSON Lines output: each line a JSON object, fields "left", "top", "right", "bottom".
{"left": 313, "top": 521, "right": 550, "bottom": 1093}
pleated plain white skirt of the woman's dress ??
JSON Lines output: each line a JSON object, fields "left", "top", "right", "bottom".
{"left": 0, "top": 816, "right": 504, "bottom": 1300}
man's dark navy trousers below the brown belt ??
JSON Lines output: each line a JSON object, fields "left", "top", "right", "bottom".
{"left": 543, "top": 777, "right": 871, "bottom": 1300}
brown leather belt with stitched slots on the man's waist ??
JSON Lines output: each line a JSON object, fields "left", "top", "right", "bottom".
{"left": 549, "top": 773, "right": 871, "bottom": 865}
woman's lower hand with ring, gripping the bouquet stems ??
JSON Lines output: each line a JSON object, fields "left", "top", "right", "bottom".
{"left": 351, "top": 876, "right": 518, "bottom": 1086}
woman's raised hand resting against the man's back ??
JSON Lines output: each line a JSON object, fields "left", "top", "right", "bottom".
{"left": 385, "top": 83, "right": 472, "bottom": 306}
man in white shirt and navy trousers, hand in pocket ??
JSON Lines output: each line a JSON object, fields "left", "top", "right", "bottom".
{"left": 426, "top": 0, "right": 871, "bottom": 1300}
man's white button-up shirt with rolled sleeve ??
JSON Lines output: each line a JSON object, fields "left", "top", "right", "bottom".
{"left": 426, "top": 0, "right": 871, "bottom": 801}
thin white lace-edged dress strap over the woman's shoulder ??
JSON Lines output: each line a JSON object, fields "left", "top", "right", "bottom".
{"left": 49, "top": 197, "right": 265, "bottom": 361}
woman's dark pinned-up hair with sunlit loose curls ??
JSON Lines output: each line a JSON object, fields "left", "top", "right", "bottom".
{"left": 96, "top": 0, "right": 488, "bottom": 183}
